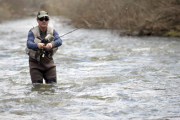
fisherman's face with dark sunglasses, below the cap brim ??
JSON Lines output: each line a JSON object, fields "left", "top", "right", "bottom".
{"left": 37, "top": 16, "right": 49, "bottom": 28}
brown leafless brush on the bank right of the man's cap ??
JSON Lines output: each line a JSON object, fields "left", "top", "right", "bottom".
{"left": 0, "top": 0, "right": 180, "bottom": 36}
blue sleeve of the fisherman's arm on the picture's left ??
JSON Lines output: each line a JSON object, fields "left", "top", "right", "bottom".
{"left": 27, "top": 31, "right": 38, "bottom": 50}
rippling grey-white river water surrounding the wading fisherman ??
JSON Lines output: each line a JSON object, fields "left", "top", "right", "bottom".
{"left": 0, "top": 17, "right": 180, "bottom": 120}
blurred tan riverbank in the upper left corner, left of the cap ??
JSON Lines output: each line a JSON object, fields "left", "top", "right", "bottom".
{"left": 0, "top": 0, "right": 40, "bottom": 23}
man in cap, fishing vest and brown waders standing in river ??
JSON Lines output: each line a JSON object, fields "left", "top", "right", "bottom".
{"left": 26, "top": 11, "right": 62, "bottom": 84}
